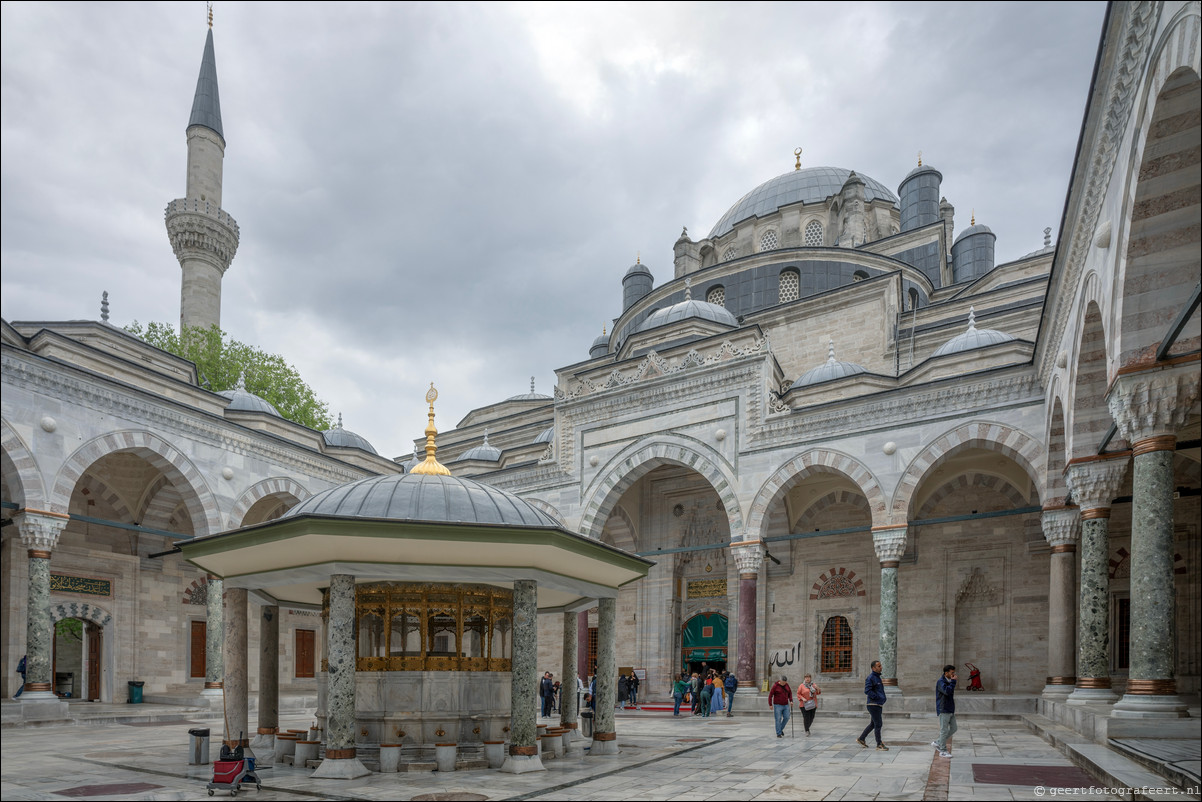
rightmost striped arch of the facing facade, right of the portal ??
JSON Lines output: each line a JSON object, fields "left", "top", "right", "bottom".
{"left": 891, "top": 421, "right": 1046, "bottom": 524}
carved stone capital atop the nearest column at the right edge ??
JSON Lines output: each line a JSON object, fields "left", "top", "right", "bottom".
{"left": 1106, "top": 357, "right": 1202, "bottom": 453}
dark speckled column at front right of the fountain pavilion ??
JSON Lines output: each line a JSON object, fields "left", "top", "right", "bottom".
{"left": 501, "top": 580, "right": 546, "bottom": 774}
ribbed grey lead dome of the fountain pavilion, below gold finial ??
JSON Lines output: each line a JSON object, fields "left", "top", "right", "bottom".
{"left": 282, "top": 474, "right": 560, "bottom": 529}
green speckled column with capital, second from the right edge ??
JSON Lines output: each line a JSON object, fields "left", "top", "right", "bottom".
{"left": 1065, "top": 461, "right": 1131, "bottom": 705}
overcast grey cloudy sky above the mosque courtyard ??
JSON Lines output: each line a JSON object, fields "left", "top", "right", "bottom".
{"left": 0, "top": 2, "right": 1105, "bottom": 457}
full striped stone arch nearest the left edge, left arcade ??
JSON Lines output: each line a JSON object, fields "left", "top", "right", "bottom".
{"left": 49, "top": 429, "right": 221, "bottom": 535}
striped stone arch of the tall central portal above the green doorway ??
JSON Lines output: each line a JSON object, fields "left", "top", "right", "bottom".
{"left": 579, "top": 435, "right": 743, "bottom": 540}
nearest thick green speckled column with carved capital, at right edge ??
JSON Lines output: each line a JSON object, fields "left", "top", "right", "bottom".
{"left": 1106, "top": 357, "right": 1200, "bottom": 718}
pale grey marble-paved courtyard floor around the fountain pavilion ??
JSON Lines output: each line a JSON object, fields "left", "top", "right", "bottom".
{"left": 0, "top": 713, "right": 1120, "bottom": 801}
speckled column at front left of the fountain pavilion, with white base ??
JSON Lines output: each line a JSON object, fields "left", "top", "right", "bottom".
{"left": 310, "top": 574, "right": 371, "bottom": 779}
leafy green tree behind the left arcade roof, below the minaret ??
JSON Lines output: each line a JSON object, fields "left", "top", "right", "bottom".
{"left": 125, "top": 321, "right": 331, "bottom": 432}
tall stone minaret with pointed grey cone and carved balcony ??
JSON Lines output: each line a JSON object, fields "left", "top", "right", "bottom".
{"left": 166, "top": 21, "right": 238, "bottom": 328}
